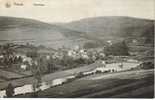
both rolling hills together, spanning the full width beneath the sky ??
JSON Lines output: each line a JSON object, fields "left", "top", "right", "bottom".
{"left": 0, "top": 16, "right": 154, "bottom": 48}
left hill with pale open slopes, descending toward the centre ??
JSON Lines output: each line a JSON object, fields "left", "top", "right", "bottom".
{"left": 0, "top": 17, "right": 85, "bottom": 48}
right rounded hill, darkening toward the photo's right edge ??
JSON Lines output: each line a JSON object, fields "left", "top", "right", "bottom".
{"left": 65, "top": 16, "right": 154, "bottom": 43}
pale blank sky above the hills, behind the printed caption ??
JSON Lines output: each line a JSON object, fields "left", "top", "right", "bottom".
{"left": 0, "top": 0, "right": 155, "bottom": 22}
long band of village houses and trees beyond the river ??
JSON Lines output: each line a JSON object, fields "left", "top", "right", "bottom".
{"left": 0, "top": 40, "right": 142, "bottom": 72}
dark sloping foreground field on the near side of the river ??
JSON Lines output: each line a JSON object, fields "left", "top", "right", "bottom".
{"left": 14, "top": 69, "right": 154, "bottom": 98}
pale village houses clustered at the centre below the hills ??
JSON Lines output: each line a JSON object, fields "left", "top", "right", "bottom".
{"left": 52, "top": 46, "right": 105, "bottom": 61}
